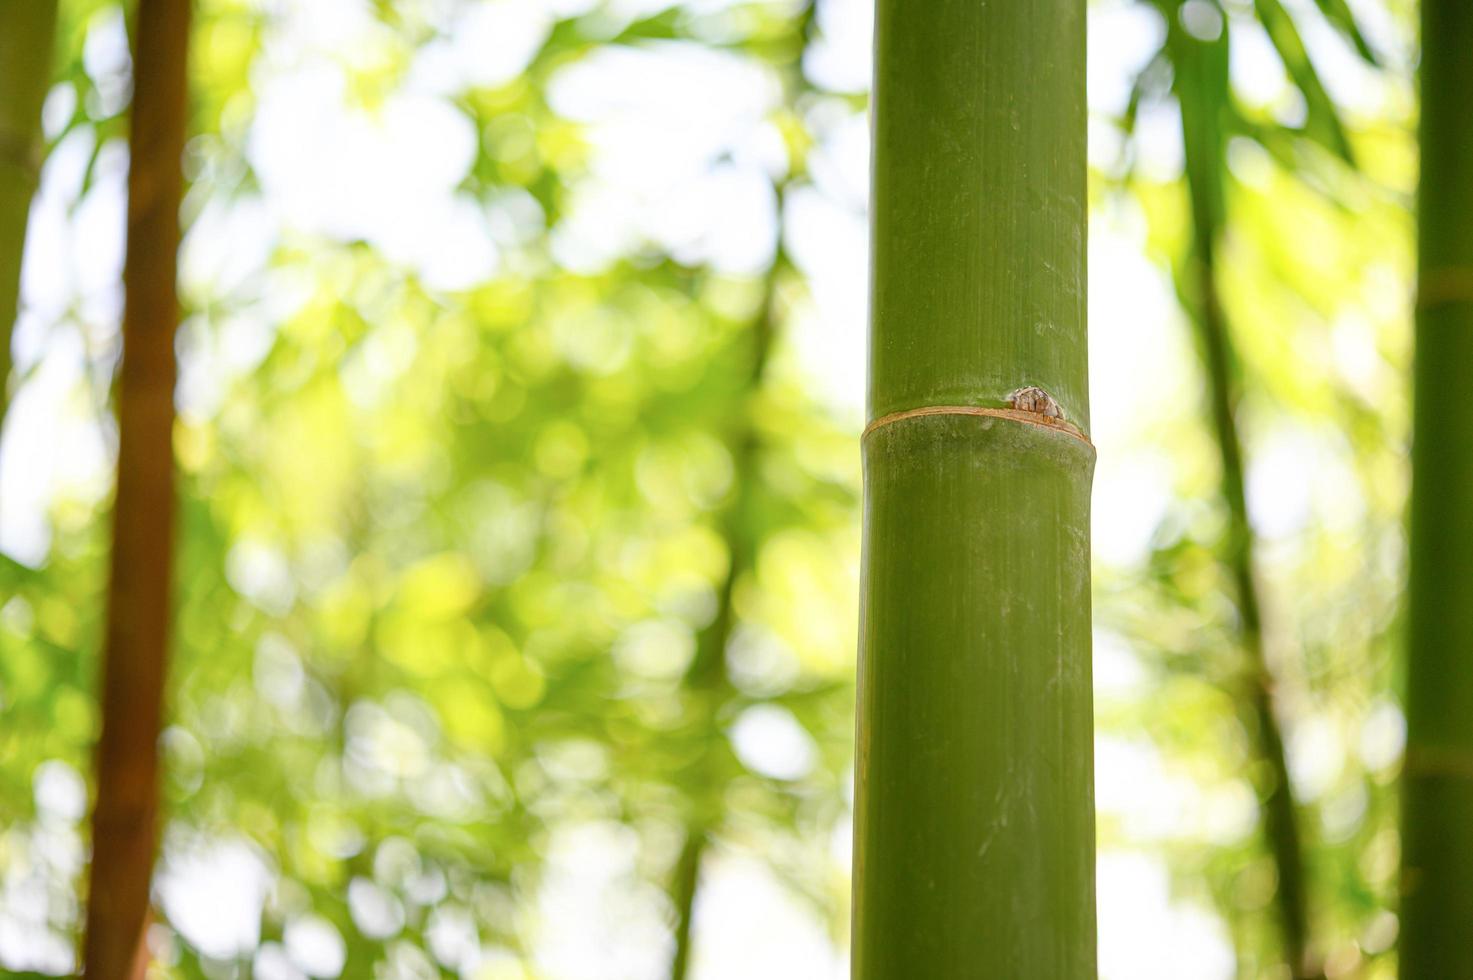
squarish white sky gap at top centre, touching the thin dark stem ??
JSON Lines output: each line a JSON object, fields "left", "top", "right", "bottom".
{"left": 548, "top": 41, "right": 785, "bottom": 274}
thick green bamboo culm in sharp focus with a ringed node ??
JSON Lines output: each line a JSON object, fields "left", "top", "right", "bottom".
{"left": 853, "top": 0, "right": 1096, "bottom": 980}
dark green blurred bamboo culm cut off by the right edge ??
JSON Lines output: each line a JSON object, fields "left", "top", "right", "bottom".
{"left": 1401, "top": 0, "right": 1473, "bottom": 980}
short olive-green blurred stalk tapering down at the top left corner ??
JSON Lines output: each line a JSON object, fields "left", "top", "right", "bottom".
{"left": 0, "top": 0, "right": 56, "bottom": 432}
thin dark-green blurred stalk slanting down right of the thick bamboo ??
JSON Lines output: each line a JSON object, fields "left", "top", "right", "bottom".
{"left": 1171, "top": 19, "right": 1320, "bottom": 977}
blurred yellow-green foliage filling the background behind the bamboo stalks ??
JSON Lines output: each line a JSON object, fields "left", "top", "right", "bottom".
{"left": 0, "top": 0, "right": 1414, "bottom": 980}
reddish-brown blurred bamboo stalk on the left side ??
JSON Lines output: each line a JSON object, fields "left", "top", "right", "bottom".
{"left": 84, "top": 0, "right": 190, "bottom": 980}
